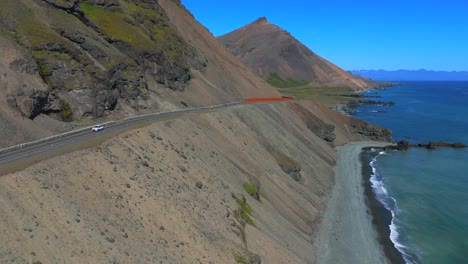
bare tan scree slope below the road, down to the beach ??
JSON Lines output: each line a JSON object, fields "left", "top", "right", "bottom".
{"left": 0, "top": 99, "right": 392, "bottom": 263}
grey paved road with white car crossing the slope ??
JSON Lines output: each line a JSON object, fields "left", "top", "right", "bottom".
{"left": 0, "top": 101, "right": 277, "bottom": 171}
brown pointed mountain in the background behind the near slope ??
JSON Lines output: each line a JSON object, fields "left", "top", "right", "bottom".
{"left": 218, "top": 17, "right": 372, "bottom": 89}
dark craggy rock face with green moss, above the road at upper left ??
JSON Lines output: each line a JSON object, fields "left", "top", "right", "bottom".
{"left": 0, "top": 0, "right": 207, "bottom": 120}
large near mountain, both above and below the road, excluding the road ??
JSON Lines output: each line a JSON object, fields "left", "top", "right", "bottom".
{"left": 0, "top": 0, "right": 390, "bottom": 263}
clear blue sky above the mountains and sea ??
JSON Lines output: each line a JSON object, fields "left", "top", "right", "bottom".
{"left": 182, "top": 0, "right": 468, "bottom": 71}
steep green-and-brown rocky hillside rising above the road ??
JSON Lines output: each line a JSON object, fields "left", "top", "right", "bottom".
{"left": 0, "top": 0, "right": 277, "bottom": 146}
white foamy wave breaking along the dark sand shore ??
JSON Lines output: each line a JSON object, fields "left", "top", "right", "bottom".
{"left": 369, "top": 155, "right": 416, "bottom": 264}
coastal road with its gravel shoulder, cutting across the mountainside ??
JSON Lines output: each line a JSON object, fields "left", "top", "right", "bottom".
{"left": 0, "top": 99, "right": 295, "bottom": 175}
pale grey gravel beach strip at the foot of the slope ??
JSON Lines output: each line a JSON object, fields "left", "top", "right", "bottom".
{"left": 317, "top": 141, "right": 394, "bottom": 264}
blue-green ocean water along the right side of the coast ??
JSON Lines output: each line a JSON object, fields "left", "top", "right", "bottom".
{"left": 354, "top": 82, "right": 468, "bottom": 264}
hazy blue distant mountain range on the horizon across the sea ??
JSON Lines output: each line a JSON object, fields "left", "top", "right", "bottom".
{"left": 350, "top": 69, "right": 468, "bottom": 81}
